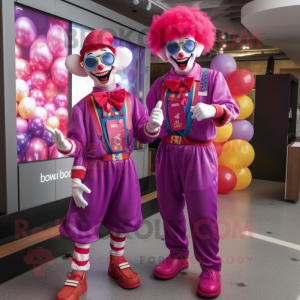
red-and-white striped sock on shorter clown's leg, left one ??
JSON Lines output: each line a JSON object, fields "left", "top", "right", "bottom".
{"left": 71, "top": 243, "right": 91, "bottom": 271}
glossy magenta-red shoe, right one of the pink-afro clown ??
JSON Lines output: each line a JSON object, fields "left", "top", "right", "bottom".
{"left": 198, "top": 266, "right": 221, "bottom": 298}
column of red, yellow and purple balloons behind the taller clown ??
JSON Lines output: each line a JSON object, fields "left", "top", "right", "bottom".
{"left": 211, "top": 54, "right": 255, "bottom": 193}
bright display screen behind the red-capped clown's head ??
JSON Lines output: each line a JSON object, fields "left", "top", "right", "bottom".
{"left": 72, "top": 23, "right": 145, "bottom": 150}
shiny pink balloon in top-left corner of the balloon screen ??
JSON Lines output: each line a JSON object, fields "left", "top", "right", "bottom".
{"left": 15, "top": 17, "right": 37, "bottom": 48}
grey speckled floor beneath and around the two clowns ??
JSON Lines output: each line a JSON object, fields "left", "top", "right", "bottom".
{"left": 0, "top": 180, "right": 300, "bottom": 300}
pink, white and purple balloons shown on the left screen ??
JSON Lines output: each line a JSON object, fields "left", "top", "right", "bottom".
{"left": 15, "top": 10, "right": 68, "bottom": 162}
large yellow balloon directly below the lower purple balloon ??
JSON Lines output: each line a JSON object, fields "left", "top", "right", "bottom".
{"left": 219, "top": 140, "right": 254, "bottom": 171}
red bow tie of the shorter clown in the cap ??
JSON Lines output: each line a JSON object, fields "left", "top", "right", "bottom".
{"left": 92, "top": 89, "right": 125, "bottom": 118}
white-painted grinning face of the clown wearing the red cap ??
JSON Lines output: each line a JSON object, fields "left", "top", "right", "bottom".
{"left": 83, "top": 48, "right": 118, "bottom": 90}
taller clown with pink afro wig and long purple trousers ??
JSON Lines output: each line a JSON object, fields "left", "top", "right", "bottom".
{"left": 146, "top": 6, "right": 239, "bottom": 297}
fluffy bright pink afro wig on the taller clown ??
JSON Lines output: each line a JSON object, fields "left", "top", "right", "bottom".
{"left": 146, "top": 5, "right": 216, "bottom": 56}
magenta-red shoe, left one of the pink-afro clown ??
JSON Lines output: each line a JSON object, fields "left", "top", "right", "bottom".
{"left": 153, "top": 255, "right": 189, "bottom": 279}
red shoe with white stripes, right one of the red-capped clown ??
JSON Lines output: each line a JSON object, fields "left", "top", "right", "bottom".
{"left": 108, "top": 255, "right": 141, "bottom": 289}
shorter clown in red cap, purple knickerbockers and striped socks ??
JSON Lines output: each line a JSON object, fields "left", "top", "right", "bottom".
{"left": 47, "top": 29, "right": 163, "bottom": 300}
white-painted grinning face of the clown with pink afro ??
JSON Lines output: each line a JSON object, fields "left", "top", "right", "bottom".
{"left": 165, "top": 37, "right": 197, "bottom": 75}
